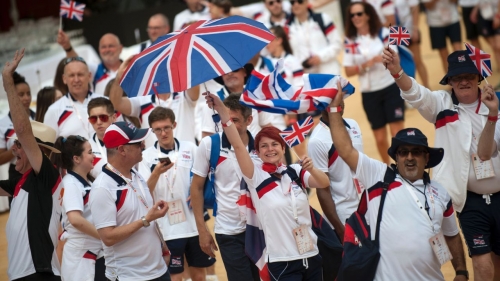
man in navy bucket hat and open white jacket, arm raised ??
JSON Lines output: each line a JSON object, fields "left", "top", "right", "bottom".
{"left": 382, "top": 47, "right": 500, "bottom": 280}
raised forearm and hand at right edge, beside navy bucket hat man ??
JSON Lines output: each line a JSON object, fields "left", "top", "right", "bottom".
{"left": 477, "top": 84, "right": 498, "bottom": 161}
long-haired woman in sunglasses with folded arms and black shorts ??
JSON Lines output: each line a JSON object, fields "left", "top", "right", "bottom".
{"left": 344, "top": 2, "right": 405, "bottom": 164}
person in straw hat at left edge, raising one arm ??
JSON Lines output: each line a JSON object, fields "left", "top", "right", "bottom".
{"left": 0, "top": 49, "right": 62, "bottom": 281}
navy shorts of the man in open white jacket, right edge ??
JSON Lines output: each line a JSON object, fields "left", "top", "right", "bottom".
{"left": 457, "top": 191, "right": 500, "bottom": 256}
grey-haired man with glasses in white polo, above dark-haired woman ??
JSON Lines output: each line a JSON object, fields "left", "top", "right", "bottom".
{"left": 44, "top": 57, "right": 100, "bottom": 139}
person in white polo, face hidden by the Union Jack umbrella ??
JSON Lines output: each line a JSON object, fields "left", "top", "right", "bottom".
{"left": 109, "top": 60, "right": 200, "bottom": 147}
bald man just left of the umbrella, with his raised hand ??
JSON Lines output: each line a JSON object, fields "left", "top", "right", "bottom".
{"left": 57, "top": 30, "right": 123, "bottom": 95}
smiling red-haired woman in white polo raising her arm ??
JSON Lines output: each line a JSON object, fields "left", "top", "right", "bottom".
{"left": 207, "top": 94, "right": 329, "bottom": 281}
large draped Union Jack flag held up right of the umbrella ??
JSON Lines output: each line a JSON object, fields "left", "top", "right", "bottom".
{"left": 240, "top": 59, "right": 355, "bottom": 114}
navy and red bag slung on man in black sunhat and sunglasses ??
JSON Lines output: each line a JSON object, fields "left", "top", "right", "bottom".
{"left": 337, "top": 167, "right": 396, "bottom": 281}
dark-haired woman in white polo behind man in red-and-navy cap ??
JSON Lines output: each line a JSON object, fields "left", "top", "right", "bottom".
{"left": 55, "top": 136, "right": 102, "bottom": 281}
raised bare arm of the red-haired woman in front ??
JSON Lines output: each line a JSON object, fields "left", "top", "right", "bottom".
{"left": 206, "top": 93, "right": 254, "bottom": 179}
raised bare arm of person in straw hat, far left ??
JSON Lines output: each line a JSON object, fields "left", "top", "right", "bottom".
{"left": 2, "top": 49, "right": 43, "bottom": 174}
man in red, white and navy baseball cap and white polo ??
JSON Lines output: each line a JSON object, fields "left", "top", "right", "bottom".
{"left": 89, "top": 122, "right": 170, "bottom": 281}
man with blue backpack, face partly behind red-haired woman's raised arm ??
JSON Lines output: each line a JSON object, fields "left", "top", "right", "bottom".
{"left": 191, "top": 95, "right": 260, "bottom": 281}
